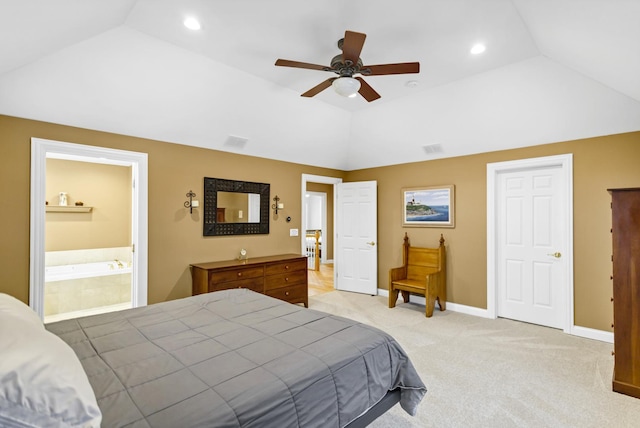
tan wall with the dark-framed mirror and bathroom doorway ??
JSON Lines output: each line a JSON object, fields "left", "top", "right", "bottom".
{"left": 0, "top": 115, "right": 344, "bottom": 303}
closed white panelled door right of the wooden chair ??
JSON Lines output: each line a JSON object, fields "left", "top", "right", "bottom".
{"left": 496, "top": 166, "right": 567, "bottom": 328}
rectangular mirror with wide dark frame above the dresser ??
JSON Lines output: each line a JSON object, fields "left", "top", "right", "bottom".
{"left": 203, "top": 177, "right": 270, "bottom": 236}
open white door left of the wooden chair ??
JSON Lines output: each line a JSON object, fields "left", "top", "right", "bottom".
{"left": 335, "top": 181, "right": 378, "bottom": 295}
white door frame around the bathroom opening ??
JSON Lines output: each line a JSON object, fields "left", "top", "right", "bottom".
{"left": 29, "top": 138, "right": 148, "bottom": 318}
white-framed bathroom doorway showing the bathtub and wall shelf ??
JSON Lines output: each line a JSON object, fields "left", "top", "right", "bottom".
{"left": 30, "top": 138, "right": 147, "bottom": 322}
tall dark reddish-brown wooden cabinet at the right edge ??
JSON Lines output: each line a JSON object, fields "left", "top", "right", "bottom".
{"left": 609, "top": 188, "right": 640, "bottom": 398}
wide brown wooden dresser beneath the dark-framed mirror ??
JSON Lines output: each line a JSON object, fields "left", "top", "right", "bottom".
{"left": 191, "top": 254, "right": 309, "bottom": 308}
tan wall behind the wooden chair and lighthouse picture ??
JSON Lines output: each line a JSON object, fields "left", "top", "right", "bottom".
{"left": 345, "top": 132, "right": 640, "bottom": 331}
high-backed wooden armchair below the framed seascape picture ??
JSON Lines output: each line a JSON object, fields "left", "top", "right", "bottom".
{"left": 389, "top": 233, "right": 447, "bottom": 317}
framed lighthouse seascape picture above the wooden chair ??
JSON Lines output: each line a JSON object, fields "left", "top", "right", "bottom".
{"left": 402, "top": 184, "right": 455, "bottom": 228}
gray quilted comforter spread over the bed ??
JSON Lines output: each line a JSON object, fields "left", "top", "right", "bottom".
{"left": 47, "top": 289, "right": 426, "bottom": 428}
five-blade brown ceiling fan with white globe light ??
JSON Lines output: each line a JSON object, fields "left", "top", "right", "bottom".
{"left": 276, "top": 31, "right": 420, "bottom": 102}
